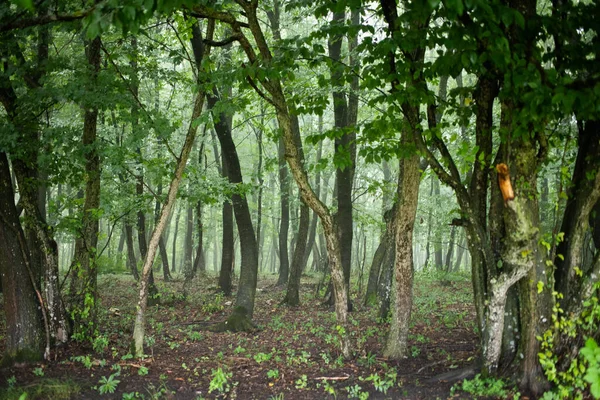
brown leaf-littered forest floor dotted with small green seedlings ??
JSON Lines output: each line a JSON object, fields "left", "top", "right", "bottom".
{"left": 0, "top": 275, "right": 510, "bottom": 399}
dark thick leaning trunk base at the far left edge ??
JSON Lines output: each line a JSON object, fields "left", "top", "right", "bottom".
{"left": 0, "top": 152, "right": 44, "bottom": 365}
